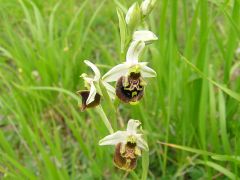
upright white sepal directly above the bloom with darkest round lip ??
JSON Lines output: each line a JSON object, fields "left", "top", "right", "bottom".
{"left": 126, "top": 41, "right": 145, "bottom": 65}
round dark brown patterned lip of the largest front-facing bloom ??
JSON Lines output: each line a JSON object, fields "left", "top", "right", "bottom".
{"left": 116, "top": 72, "right": 144, "bottom": 103}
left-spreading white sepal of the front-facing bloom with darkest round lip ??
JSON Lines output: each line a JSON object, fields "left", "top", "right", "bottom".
{"left": 102, "top": 63, "right": 130, "bottom": 82}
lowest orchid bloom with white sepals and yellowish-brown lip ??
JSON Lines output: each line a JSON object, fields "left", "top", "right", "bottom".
{"left": 99, "top": 119, "right": 148, "bottom": 171}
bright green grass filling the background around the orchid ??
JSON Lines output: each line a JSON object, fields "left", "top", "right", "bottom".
{"left": 0, "top": 0, "right": 240, "bottom": 180}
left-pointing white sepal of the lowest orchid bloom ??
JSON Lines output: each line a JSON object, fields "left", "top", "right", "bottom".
{"left": 99, "top": 131, "right": 127, "bottom": 146}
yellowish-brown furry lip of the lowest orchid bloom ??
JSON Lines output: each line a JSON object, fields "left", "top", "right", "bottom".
{"left": 113, "top": 142, "right": 138, "bottom": 171}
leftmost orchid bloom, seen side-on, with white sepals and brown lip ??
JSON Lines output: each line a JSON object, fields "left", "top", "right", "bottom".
{"left": 77, "top": 60, "right": 115, "bottom": 111}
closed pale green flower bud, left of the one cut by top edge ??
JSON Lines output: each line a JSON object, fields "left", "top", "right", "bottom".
{"left": 125, "top": 3, "right": 141, "bottom": 29}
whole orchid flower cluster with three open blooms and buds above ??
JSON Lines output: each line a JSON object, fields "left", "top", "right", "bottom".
{"left": 78, "top": 0, "right": 158, "bottom": 171}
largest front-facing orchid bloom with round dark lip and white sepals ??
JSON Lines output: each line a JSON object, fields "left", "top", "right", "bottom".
{"left": 102, "top": 30, "right": 158, "bottom": 104}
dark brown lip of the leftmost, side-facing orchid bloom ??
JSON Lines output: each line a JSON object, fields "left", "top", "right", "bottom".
{"left": 77, "top": 90, "right": 101, "bottom": 111}
